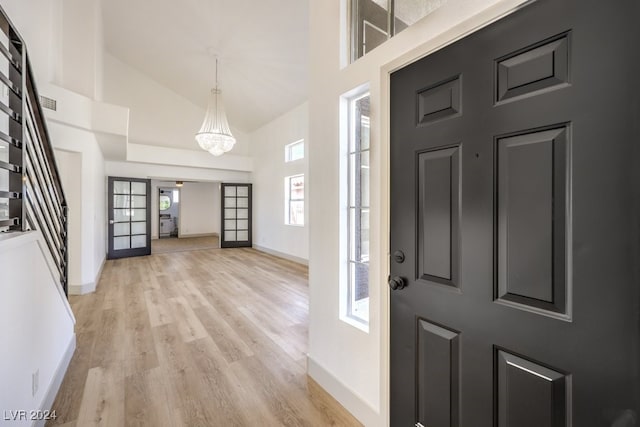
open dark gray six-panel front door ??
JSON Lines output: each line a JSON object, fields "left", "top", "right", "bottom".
{"left": 390, "top": 0, "right": 640, "bottom": 427}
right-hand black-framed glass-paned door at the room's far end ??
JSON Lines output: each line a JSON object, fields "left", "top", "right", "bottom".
{"left": 220, "top": 184, "right": 251, "bottom": 248}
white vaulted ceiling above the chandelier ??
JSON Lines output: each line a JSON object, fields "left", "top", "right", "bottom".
{"left": 103, "top": 0, "right": 308, "bottom": 132}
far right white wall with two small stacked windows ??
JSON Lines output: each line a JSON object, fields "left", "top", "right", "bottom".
{"left": 251, "top": 103, "right": 311, "bottom": 262}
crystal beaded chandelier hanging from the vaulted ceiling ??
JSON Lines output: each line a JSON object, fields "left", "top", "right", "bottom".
{"left": 196, "top": 57, "right": 236, "bottom": 156}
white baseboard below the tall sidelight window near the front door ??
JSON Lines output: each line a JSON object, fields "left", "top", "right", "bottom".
{"left": 307, "top": 356, "right": 386, "bottom": 427}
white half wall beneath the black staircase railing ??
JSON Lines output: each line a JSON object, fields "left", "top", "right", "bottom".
{"left": 0, "top": 231, "right": 75, "bottom": 427}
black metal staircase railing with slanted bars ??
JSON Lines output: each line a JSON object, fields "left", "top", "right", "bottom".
{"left": 0, "top": 7, "right": 68, "bottom": 293}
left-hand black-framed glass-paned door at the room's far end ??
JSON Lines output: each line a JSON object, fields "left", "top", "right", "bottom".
{"left": 107, "top": 177, "right": 151, "bottom": 259}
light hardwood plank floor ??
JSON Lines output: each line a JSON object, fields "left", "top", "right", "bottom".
{"left": 49, "top": 249, "right": 360, "bottom": 427}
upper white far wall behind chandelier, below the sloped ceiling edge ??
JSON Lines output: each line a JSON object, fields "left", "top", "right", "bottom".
{"left": 104, "top": 53, "right": 249, "bottom": 156}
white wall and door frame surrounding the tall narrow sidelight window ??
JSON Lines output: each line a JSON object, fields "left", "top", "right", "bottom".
{"left": 308, "top": 0, "right": 523, "bottom": 426}
